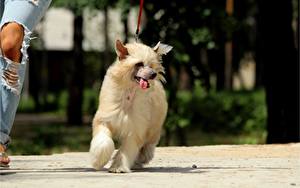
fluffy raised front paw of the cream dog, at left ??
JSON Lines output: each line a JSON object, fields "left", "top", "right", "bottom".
{"left": 90, "top": 126, "right": 115, "bottom": 170}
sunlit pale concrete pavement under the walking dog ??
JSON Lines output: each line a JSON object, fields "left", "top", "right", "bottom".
{"left": 0, "top": 143, "right": 300, "bottom": 188}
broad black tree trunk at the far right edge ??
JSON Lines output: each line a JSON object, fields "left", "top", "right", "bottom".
{"left": 258, "top": 0, "right": 300, "bottom": 143}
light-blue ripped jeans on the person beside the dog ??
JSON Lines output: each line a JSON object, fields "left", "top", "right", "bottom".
{"left": 0, "top": 0, "right": 51, "bottom": 147}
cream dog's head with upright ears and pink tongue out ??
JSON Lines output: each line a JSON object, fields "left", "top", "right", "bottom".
{"left": 114, "top": 40, "right": 172, "bottom": 89}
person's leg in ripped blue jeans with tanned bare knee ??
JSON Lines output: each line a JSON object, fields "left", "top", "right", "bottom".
{"left": 0, "top": 0, "right": 51, "bottom": 151}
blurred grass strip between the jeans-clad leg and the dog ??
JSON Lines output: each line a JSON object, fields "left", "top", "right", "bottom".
{"left": 9, "top": 124, "right": 91, "bottom": 155}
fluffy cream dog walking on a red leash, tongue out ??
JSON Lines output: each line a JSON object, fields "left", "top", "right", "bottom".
{"left": 89, "top": 40, "right": 172, "bottom": 173}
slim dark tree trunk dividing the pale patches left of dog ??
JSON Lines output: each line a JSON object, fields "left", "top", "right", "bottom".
{"left": 67, "top": 14, "right": 84, "bottom": 125}
